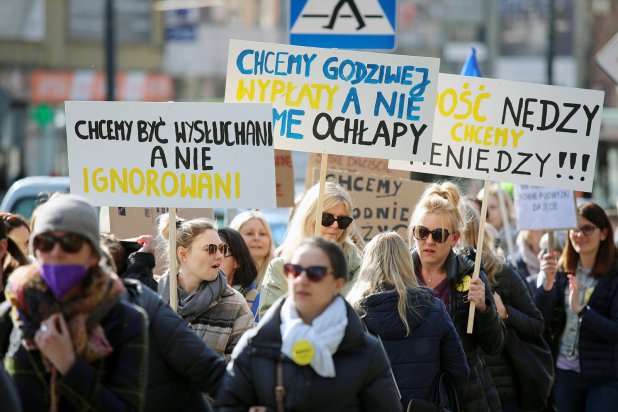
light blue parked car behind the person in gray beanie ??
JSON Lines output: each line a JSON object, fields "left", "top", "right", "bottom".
{"left": 0, "top": 176, "right": 71, "bottom": 219}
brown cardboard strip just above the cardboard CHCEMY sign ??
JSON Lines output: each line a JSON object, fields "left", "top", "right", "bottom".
{"left": 305, "top": 153, "right": 410, "bottom": 189}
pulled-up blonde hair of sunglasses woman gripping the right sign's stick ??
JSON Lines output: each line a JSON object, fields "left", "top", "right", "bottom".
{"left": 408, "top": 181, "right": 465, "bottom": 244}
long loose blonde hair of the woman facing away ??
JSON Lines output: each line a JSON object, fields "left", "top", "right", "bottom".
{"left": 346, "top": 231, "right": 431, "bottom": 336}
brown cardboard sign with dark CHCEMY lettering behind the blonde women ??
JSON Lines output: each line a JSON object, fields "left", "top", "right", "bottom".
{"left": 313, "top": 168, "right": 426, "bottom": 242}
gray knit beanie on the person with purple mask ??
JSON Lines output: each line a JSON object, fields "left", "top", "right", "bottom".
{"left": 30, "top": 195, "right": 104, "bottom": 256}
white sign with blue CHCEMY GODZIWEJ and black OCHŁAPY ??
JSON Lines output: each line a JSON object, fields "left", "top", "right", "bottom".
{"left": 225, "top": 40, "right": 439, "bottom": 160}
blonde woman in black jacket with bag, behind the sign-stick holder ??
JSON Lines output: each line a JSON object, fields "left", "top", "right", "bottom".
{"left": 460, "top": 202, "right": 551, "bottom": 412}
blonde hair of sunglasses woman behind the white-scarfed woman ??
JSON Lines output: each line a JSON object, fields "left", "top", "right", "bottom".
{"left": 281, "top": 182, "right": 360, "bottom": 259}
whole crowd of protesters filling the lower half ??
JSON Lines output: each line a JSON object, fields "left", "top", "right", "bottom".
{"left": 0, "top": 181, "right": 618, "bottom": 412}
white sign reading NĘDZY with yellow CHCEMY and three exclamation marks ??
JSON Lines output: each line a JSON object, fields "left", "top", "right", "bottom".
{"left": 388, "top": 74, "right": 604, "bottom": 192}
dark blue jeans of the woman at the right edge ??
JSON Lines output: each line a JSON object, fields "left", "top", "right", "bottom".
{"left": 554, "top": 369, "right": 618, "bottom": 412}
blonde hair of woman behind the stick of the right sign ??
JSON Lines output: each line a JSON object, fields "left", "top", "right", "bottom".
{"left": 459, "top": 202, "right": 505, "bottom": 285}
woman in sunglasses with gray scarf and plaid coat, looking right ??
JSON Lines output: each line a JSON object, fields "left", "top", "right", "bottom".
{"left": 159, "top": 214, "right": 254, "bottom": 360}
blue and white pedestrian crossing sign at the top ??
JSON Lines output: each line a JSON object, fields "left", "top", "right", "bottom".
{"left": 290, "top": 0, "right": 397, "bottom": 50}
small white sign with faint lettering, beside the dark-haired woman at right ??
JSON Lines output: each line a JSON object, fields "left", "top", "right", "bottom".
{"left": 515, "top": 185, "right": 577, "bottom": 230}
